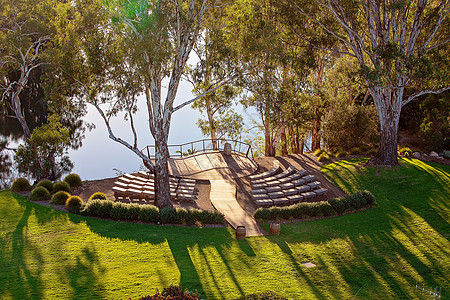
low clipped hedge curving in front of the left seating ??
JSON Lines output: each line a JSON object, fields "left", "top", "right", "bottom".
{"left": 79, "top": 199, "right": 225, "bottom": 225}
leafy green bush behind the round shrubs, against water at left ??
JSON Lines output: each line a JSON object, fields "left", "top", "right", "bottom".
{"left": 15, "top": 115, "right": 73, "bottom": 180}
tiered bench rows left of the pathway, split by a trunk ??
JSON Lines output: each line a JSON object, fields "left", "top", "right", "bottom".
{"left": 112, "top": 171, "right": 196, "bottom": 201}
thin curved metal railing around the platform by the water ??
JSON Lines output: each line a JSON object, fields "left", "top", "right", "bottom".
{"left": 141, "top": 139, "right": 253, "bottom": 158}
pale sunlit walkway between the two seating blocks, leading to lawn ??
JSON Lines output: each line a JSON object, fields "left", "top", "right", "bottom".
{"left": 210, "top": 179, "right": 265, "bottom": 236}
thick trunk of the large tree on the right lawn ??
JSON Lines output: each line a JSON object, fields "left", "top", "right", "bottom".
{"left": 371, "top": 87, "right": 403, "bottom": 166}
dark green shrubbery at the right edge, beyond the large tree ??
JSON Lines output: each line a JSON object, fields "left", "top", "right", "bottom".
{"left": 419, "top": 92, "right": 450, "bottom": 150}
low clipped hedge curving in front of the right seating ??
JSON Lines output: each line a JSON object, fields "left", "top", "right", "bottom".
{"left": 254, "top": 191, "right": 375, "bottom": 222}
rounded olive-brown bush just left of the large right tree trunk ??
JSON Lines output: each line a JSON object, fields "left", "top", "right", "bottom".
{"left": 322, "top": 104, "right": 378, "bottom": 151}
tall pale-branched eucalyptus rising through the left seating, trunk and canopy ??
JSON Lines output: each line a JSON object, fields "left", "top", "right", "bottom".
{"left": 78, "top": 0, "right": 227, "bottom": 207}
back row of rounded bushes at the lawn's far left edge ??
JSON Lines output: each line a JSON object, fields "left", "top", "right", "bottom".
{"left": 11, "top": 174, "right": 82, "bottom": 192}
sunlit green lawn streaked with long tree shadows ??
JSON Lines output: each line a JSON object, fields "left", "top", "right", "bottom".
{"left": 0, "top": 159, "right": 450, "bottom": 299}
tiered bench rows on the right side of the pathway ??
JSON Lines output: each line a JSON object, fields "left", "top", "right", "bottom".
{"left": 249, "top": 162, "right": 328, "bottom": 207}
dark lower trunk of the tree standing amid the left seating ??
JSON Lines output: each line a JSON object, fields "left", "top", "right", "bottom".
{"left": 155, "top": 128, "right": 173, "bottom": 208}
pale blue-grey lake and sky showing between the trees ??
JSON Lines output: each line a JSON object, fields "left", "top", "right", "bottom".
{"left": 69, "top": 81, "right": 257, "bottom": 180}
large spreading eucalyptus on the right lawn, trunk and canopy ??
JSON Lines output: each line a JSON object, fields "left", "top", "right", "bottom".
{"left": 272, "top": 0, "right": 450, "bottom": 165}
